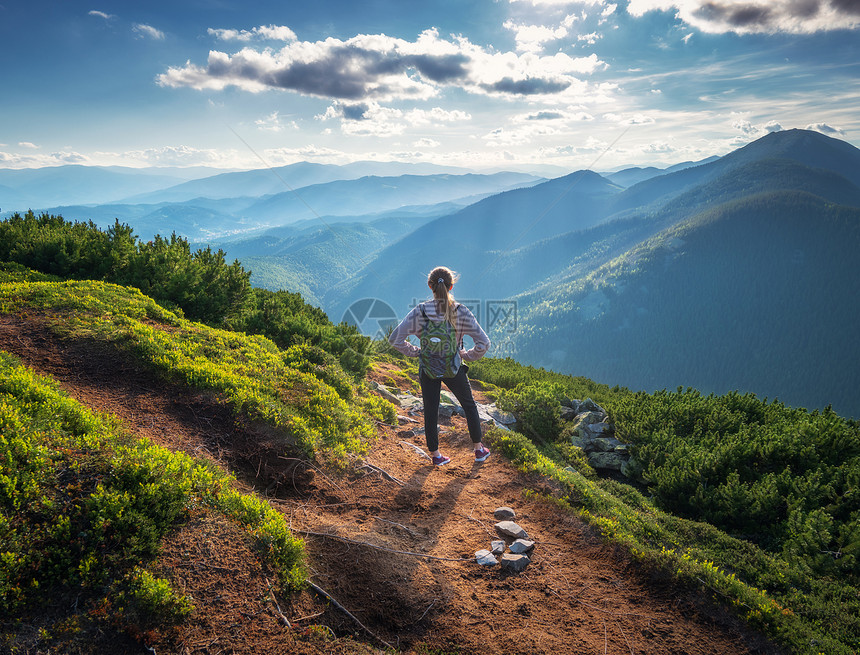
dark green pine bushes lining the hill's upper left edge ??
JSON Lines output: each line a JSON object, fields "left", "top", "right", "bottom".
{"left": 0, "top": 211, "right": 370, "bottom": 377}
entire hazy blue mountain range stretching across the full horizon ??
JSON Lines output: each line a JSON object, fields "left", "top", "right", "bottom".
{"left": 0, "top": 130, "right": 860, "bottom": 418}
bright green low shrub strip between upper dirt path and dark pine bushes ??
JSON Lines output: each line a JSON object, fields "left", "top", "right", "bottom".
{"left": 0, "top": 274, "right": 393, "bottom": 465}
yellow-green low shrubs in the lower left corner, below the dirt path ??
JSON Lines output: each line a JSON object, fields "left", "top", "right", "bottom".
{"left": 0, "top": 353, "right": 306, "bottom": 645}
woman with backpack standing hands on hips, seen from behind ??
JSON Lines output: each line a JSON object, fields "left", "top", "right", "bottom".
{"left": 388, "top": 266, "right": 490, "bottom": 466}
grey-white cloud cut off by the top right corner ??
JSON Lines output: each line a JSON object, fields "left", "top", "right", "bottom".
{"left": 627, "top": 0, "right": 860, "bottom": 34}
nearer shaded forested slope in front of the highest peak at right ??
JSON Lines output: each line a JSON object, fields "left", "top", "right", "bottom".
{"left": 510, "top": 192, "right": 860, "bottom": 415}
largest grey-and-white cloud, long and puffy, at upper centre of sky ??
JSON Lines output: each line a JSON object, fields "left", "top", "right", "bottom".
{"left": 157, "top": 29, "right": 606, "bottom": 103}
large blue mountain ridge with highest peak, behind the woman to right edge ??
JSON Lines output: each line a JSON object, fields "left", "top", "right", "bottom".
{"left": 314, "top": 130, "right": 860, "bottom": 417}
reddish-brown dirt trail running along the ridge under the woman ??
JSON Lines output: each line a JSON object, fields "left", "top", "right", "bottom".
{"left": 0, "top": 316, "right": 777, "bottom": 655}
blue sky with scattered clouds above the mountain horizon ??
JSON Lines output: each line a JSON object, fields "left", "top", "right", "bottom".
{"left": 0, "top": 0, "right": 860, "bottom": 170}
